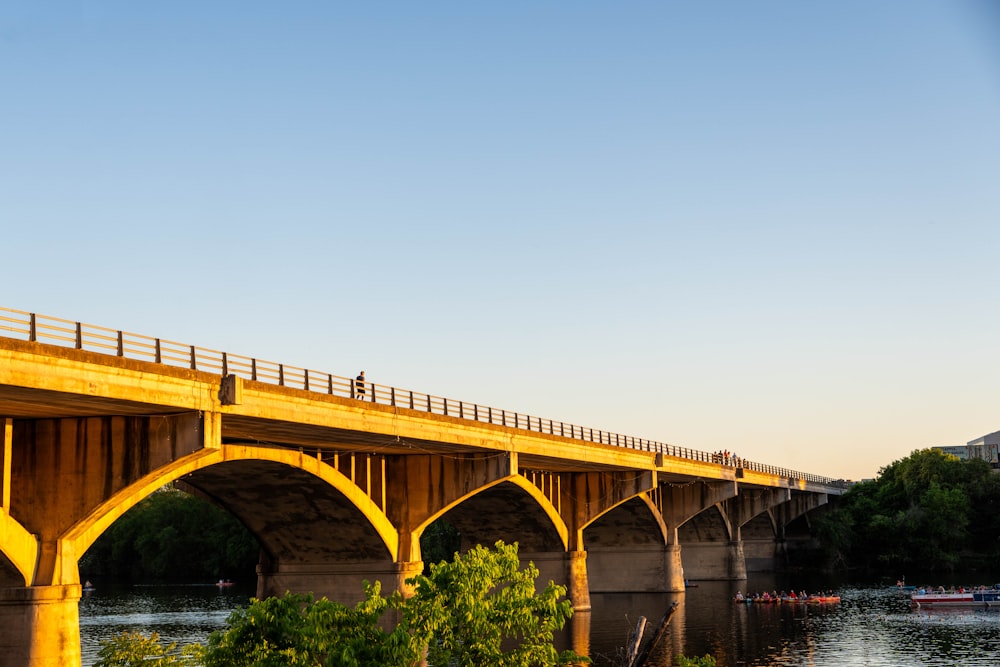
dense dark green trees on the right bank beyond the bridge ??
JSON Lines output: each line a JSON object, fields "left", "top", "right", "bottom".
{"left": 816, "top": 449, "right": 1000, "bottom": 571}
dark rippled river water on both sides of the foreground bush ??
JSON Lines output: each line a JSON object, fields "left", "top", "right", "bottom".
{"left": 80, "top": 576, "right": 1000, "bottom": 667}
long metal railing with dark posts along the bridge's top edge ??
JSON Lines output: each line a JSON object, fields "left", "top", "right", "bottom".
{"left": 0, "top": 308, "right": 849, "bottom": 488}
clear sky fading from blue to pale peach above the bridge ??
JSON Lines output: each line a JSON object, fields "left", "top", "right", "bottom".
{"left": 0, "top": 0, "right": 1000, "bottom": 479}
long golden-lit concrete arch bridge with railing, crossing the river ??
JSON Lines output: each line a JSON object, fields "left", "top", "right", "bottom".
{"left": 0, "top": 309, "right": 847, "bottom": 667}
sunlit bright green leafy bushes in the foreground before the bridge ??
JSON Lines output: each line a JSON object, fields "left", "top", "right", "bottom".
{"left": 197, "top": 542, "right": 588, "bottom": 667}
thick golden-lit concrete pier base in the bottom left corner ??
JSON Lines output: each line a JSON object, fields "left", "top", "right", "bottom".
{"left": 0, "top": 584, "right": 81, "bottom": 667}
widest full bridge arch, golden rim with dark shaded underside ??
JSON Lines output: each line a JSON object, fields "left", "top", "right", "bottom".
{"left": 60, "top": 445, "right": 399, "bottom": 582}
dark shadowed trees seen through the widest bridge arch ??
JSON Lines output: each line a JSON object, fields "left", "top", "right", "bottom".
{"left": 80, "top": 488, "right": 260, "bottom": 581}
